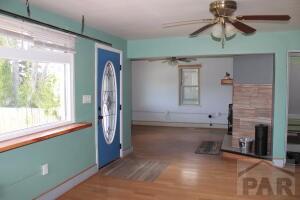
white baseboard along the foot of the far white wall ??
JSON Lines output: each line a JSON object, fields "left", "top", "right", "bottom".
{"left": 132, "top": 121, "right": 227, "bottom": 129}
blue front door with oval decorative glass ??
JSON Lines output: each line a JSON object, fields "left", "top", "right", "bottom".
{"left": 97, "top": 48, "right": 120, "bottom": 167}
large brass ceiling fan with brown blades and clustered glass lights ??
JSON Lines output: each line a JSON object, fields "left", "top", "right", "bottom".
{"left": 163, "top": 0, "right": 291, "bottom": 48}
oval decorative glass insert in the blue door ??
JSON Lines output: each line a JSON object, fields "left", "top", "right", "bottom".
{"left": 101, "top": 61, "right": 118, "bottom": 144}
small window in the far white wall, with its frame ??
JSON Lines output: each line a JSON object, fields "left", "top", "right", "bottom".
{"left": 179, "top": 65, "right": 201, "bottom": 105}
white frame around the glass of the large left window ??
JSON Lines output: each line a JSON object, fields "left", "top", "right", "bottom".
{"left": 0, "top": 47, "right": 75, "bottom": 141}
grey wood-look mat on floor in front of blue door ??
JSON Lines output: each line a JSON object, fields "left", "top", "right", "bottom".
{"left": 100, "top": 158, "right": 168, "bottom": 182}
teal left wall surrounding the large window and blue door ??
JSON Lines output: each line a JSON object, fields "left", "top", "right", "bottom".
{"left": 0, "top": 0, "right": 131, "bottom": 200}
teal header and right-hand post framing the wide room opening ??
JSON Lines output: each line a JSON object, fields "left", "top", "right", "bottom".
{"left": 127, "top": 31, "right": 300, "bottom": 159}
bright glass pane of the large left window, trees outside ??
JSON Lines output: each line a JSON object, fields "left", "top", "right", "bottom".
{"left": 0, "top": 58, "right": 70, "bottom": 134}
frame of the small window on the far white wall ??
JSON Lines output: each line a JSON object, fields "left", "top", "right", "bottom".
{"left": 178, "top": 64, "right": 201, "bottom": 106}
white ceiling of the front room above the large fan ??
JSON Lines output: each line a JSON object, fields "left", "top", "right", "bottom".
{"left": 30, "top": 0, "right": 300, "bottom": 39}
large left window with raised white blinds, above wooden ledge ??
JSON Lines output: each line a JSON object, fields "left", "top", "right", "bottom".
{"left": 0, "top": 17, "right": 74, "bottom": 141}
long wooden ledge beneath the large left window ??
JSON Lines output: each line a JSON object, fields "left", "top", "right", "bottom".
{"left": 0, "top": 122, "right": 92, "bottom": 153}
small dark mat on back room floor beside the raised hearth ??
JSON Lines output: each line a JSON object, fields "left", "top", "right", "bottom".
{"left": 195, "top": 141, "right": 222, "bottom": 155}
